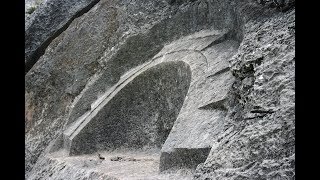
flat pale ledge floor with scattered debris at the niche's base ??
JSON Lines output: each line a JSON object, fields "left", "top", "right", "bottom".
{"left": 50, "top": 150, "right": 193, "bottom": 180}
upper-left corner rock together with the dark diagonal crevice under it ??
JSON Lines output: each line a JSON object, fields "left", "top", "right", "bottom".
{"left": 25, "top": 0, "right": 98, "bottom": 73}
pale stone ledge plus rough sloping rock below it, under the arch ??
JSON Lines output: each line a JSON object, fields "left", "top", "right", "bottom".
{"left": 29, "top": 151, "right": 198, "bottom": 180}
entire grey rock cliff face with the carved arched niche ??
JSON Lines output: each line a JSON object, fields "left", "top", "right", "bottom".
{"left": 25, "top": 0, "right": 295, "bottom": 179}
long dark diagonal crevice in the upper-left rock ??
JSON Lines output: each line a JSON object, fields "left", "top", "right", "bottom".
{"left": 25, "top": 0, "right": 100, "bottom": 75}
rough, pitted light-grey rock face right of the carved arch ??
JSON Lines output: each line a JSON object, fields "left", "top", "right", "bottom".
{"left": 192, "top": 7, "right": 295, "bottom": 179}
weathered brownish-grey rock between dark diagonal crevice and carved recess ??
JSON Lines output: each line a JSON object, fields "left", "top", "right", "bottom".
{"left": 25, "top": 1, "right": 167, "bottom": 172}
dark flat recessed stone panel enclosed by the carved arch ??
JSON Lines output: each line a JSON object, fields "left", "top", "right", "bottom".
{"left": 70, "top": 61, "right": 191, "bottom": 155}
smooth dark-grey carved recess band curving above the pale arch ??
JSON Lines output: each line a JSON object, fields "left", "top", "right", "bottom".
{"left": 66, "top": 1, "right": 239, "bottom": 125}
